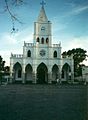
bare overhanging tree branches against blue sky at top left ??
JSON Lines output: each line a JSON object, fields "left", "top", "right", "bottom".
{"left": 0, "top": 0, "right": 25, "bottom": 33}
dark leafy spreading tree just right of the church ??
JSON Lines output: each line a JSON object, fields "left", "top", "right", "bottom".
{"left": 62, "top": 48, "right": 88, "bottom": 77}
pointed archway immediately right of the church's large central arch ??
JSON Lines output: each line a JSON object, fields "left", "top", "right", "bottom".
{"left": 52, "top": 64, "right": 59, "bottom": 81}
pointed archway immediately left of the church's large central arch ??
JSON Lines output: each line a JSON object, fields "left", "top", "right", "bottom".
{"left": 25, "top": 64, "right": 32, "bottom": 83}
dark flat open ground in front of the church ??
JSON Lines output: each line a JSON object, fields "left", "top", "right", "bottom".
{"left": 0, "top": 84, "right": 88, "bottom": 120}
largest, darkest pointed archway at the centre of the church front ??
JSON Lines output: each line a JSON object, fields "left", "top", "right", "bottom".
{"left": 37, "top": 63, "right": 48, "bottom": 84}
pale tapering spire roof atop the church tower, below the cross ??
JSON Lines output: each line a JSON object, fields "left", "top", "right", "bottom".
{"left": 37, "top": 6, "right": 48, "bottom": 22}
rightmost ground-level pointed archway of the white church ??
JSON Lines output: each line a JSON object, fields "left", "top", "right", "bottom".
{"left": 62, "top": 63, "right": 71, "bottom": 81}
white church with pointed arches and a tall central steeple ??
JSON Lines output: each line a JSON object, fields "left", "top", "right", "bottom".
{"left": 10, "top": 1, "right": 74, "bottom": 84}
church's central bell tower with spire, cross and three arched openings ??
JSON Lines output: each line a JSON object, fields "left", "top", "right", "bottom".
{"left": 34, "top": 1, "right": 52, "bottom": 46}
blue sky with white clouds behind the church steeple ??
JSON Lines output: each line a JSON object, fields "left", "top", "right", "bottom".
{"left": 0, "top": 0, "right": 88, "bottom": 65}
